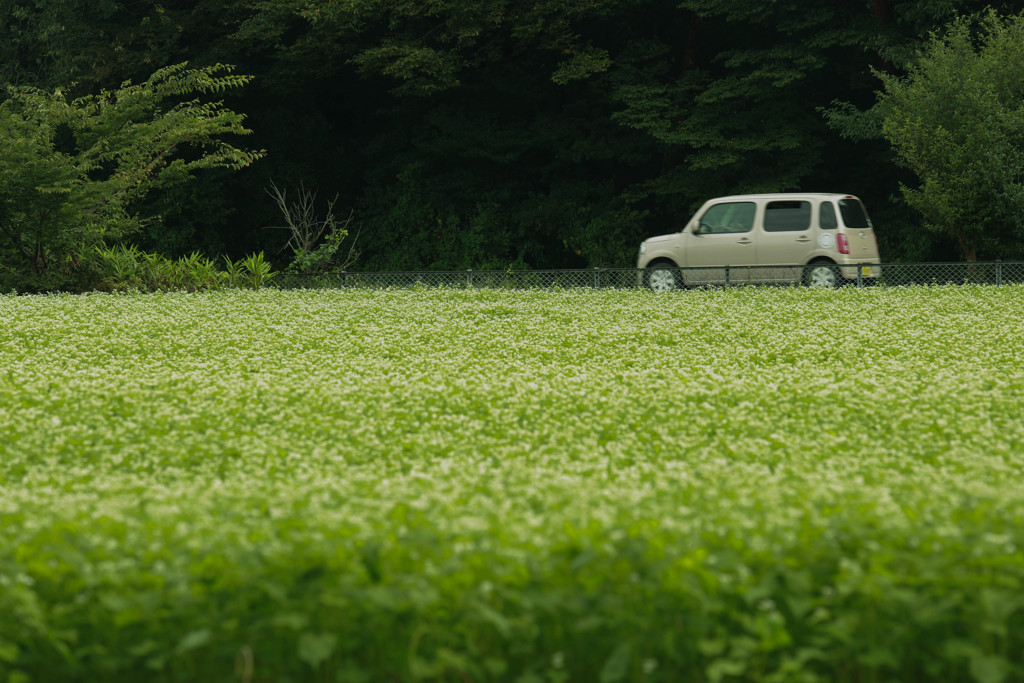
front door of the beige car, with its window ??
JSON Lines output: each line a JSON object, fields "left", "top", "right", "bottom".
{"left": 683, "top": 202, "right": 757, "bottom": 285}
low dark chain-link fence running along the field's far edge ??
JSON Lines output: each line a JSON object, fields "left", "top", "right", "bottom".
{"left": 274, "top": 261, "right": 1024, "bottom": 290}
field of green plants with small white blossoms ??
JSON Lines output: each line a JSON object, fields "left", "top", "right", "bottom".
{"left": 0, "top": 286, "right": 1024, "bottom": 683}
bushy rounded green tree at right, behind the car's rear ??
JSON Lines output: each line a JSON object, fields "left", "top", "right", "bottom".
{"left": 880, "top": 11, "right": 1024, "bottom": 261}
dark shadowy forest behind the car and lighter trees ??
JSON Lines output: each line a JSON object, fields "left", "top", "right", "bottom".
{"left": 0, "top": 0, "right": 1024, "bottom": 270}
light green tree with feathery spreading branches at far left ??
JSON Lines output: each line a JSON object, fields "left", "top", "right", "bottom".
{"left": 0, "top": 63, "right": 263, "bottom": 288}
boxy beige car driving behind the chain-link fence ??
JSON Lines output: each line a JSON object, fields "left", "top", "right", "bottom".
{"left": 637, "top": 193, "right": 881, "bottom": 291}
